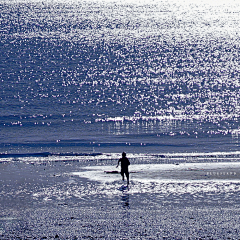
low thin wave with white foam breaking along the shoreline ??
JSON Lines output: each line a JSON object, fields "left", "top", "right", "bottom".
{"left": 0, "top": 151, "right": 240, "bottom": 165}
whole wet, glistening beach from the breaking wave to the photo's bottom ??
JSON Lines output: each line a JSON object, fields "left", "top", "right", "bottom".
{"left": 0, "top": 161, "right": 240, "bottom": 239}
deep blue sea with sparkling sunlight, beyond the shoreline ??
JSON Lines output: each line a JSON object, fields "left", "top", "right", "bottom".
{"left": 0, "top": 0, "right": 240, "bottom": 160}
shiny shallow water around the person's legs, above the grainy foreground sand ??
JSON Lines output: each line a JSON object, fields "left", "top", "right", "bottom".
{"left": 0, "top": 160, "right": 240, "bottom": 209}
